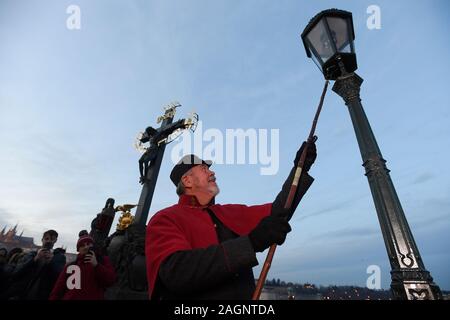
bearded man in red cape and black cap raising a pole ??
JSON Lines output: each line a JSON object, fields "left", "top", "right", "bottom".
{"left": 145, "top": 144, "right": 317, "bottom": 300}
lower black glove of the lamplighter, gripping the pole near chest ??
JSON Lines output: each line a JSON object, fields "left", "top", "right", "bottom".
{"left": 248, "top": 216, "right": 291, "bottom": 252}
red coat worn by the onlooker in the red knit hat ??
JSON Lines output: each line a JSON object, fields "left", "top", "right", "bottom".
{"left": 49, "top": 255, "right": 116, "bottom": 300}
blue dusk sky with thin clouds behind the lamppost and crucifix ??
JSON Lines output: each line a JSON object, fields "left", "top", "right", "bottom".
{"left": 0, "top": 0, "right": 450, "bottom": 290}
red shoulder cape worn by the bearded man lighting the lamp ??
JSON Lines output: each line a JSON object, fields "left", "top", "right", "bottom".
{"left": 145, "top": 195, "right": 272, "bottom": 297}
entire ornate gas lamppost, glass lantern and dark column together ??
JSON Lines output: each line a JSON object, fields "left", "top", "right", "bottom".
{"left": 302, "top": 9, "right": 442, "bottom": 300}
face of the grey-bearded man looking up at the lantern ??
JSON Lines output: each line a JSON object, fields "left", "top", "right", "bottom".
{"left": 183, "top": 164, "right": 220, "bottom": 197}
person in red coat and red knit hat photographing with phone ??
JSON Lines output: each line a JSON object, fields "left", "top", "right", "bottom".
{"left": 49, "top": 230, "right": 116, "bottom": 300}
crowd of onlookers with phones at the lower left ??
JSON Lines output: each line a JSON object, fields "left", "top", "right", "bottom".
{"left": 0, "top": 230, "right": 116, "bottom": 300}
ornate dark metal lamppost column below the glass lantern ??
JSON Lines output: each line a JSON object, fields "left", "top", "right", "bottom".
{"left": 333, "top": 73, "right": 441, "bottom": 300}
